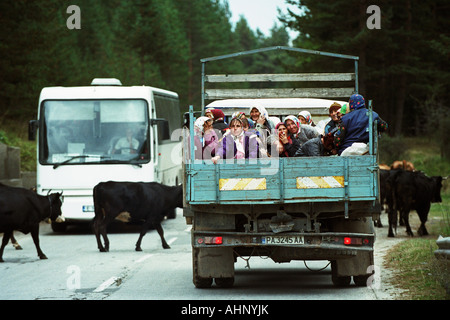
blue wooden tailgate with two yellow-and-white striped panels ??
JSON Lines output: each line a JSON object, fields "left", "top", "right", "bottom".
{"left": 186, "top": 155, "right": 378, "bottom": 205}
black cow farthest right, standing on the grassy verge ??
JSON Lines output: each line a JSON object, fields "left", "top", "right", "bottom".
{"left": 394, "top": 170, "right": 442, "bottom": 236}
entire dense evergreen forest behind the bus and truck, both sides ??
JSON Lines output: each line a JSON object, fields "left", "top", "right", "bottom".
{"left": 0, "top": 0, "right": 450, "bottom": 148}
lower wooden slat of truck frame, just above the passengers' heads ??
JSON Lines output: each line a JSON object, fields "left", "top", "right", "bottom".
{"left": 205, "top": 88, "right": 355, "bottom": 100}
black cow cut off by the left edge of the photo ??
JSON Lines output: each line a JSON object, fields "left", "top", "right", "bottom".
{"left": 0, "top": 184, "right": 62, "bottom": 262}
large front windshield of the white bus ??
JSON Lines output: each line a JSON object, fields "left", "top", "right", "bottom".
{"left": 39, "top": 99, "right": 150, "bottom": 168}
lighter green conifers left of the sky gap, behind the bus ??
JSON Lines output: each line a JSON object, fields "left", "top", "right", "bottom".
{"left": 0, "top": 0, "right": 296, "bottom": 125}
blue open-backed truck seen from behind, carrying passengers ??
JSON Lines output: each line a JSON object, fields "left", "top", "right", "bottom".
{"left": 183, "top": 47, "right": 380, "bottom": 288}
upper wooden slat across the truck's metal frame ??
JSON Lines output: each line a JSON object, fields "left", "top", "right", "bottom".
{"left": 205, "top": 73, "right": 355, "bottom": 82}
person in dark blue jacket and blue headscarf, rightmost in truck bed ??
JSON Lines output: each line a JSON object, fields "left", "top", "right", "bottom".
{"left": 334, "top": 94, "right": 388, "bottom": 155}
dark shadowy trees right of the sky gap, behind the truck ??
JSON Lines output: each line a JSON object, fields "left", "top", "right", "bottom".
{"left": 282, "top": 0, "right": 450, "bottom": 138}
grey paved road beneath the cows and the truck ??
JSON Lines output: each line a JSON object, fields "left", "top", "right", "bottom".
{"left": 0, "top": 210, "right": 400, "bottom": 305}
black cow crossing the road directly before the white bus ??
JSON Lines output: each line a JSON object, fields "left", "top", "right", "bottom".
{"left": 94, "top": 181, "right": 183, "bottom": 252}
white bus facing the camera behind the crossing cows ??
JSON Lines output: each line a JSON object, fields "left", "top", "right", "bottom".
{"left": 29, "top": 79, "right": 183, "bottom": 231}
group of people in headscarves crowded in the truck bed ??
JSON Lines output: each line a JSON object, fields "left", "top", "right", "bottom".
{"left": 194, "top": 94, "right": 388, "bottom": 163}
